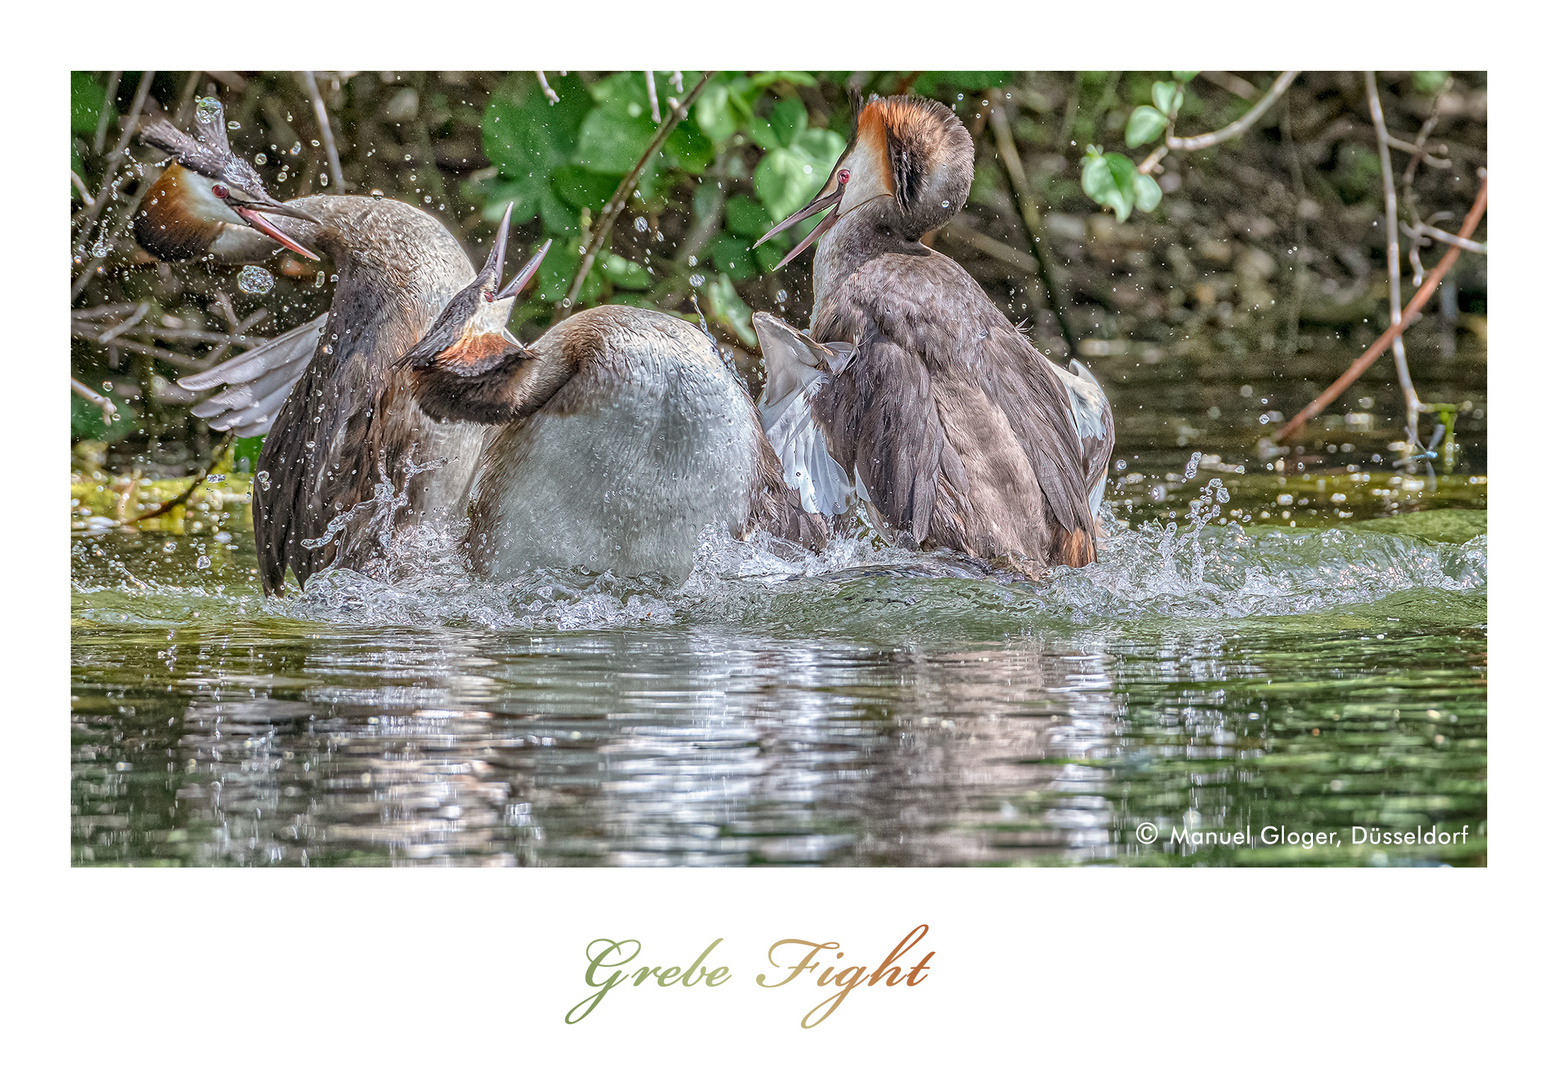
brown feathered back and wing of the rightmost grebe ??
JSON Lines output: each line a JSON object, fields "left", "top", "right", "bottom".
{"left": 812, "top": 252, "right": 1094, "bottom": 564}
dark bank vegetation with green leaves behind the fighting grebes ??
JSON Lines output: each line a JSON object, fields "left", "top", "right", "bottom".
{"left": 70, "top": 72, "right": 1486, "bottom": 477}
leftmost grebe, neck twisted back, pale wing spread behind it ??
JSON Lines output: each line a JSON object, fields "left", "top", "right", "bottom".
{"left": 136, "top": 100, "right": 495, "bottom": 592}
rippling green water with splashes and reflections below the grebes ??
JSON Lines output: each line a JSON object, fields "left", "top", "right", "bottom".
{"left": 72, "top": 455, "right": 1486, "bottom": 865}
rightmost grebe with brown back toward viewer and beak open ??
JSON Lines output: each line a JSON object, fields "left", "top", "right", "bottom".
{"left": 759, "top": 97, "right": 1114, "bottom": 572}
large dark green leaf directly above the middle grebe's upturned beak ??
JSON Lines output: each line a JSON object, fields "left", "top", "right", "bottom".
{"left": 481, "top": 72, "right": 590, "bottom": 223}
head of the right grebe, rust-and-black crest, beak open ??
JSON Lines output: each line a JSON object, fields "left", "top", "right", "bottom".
{"left": 754, "top": 97, "right": 974, "bottom": 270}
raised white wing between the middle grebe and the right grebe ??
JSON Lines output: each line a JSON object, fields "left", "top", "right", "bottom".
{"left": 753, "top": 312, "right": 855, "bottom": 516}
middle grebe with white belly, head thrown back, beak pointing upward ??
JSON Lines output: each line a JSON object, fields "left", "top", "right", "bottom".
{"left": 397, "top": 215, "right": 837, "bottom": 581}
